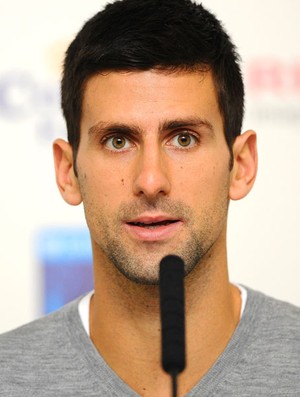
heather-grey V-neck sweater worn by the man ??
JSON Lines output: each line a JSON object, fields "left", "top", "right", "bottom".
{"left": 0, "top": 289, "right": 300, "bottom": 397}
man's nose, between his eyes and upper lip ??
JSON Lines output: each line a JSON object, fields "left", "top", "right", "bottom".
{"left": 133, "top": 146, "right": 171, "bottom": 199}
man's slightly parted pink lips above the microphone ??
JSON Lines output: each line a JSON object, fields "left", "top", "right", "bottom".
{"left": 124, "top": 215, "right": 183, "bottom": 242}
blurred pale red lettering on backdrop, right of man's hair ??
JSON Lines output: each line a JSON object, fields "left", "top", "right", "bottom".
{"left": 245, "top": 58, "right": 300, "bottom": 97}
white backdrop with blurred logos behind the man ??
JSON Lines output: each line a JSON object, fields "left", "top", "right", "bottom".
{"left": 0, "top": 0, "right": 300, "bottom": 331}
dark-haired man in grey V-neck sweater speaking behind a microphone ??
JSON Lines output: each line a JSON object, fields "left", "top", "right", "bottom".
{"left": 0, "top": 0, "right": 300, "bottom": 397}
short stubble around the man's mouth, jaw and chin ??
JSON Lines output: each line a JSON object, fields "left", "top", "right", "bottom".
{"left": 80, "top": 175, "right": 228, "bottom": 285}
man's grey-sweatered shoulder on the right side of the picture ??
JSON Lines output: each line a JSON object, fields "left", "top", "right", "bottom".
{"left": 192, "top": 287, "right": 300, "bottom": 396}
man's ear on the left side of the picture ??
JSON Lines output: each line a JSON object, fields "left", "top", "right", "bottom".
{"left": 53, "top": 139, "right": 82, "bottom": 205}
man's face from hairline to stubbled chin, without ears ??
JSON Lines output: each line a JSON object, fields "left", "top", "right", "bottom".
{"left": 77, "top": 71, "right": 230, "bottom": 284}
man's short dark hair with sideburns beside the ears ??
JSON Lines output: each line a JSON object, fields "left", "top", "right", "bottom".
{"left": 61, "top": 0, "right": 244, "bottom": 166}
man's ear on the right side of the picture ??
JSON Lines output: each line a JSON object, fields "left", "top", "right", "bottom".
{"left": 229, "top": 130, "right": 257, "bottom": 200}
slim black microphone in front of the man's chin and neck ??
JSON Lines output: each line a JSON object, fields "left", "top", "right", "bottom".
{"left": 159, "top": 255, "right": 185, "bottom": 397}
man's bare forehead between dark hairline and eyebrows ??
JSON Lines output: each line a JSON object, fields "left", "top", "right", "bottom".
{"left": 81, "top": 70, "right": 222, "bottom": 128}
